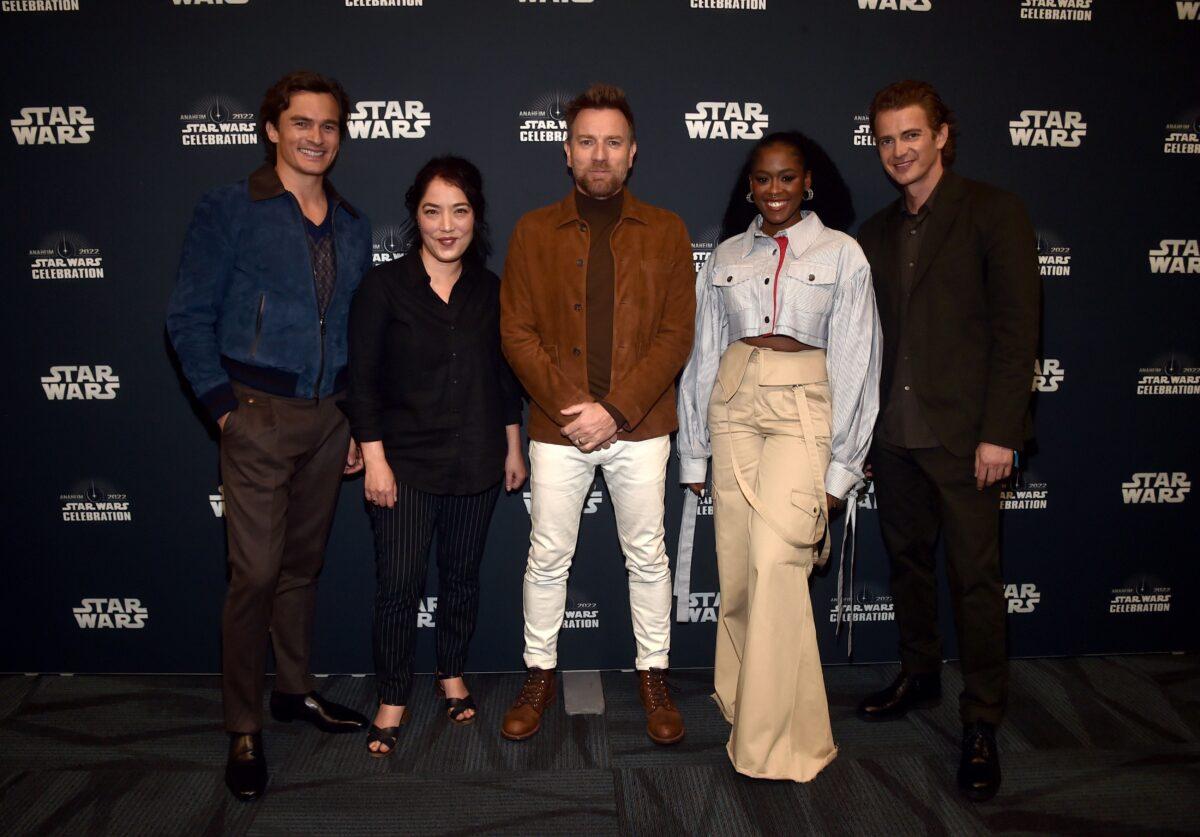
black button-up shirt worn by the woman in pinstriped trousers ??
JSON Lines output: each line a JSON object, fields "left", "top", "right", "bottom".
{"left": 343, "top": 253, "right": 521, "bottom": 494}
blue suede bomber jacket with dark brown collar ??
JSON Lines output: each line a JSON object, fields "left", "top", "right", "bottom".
{"left": 167, "top": 164, "right": 371, "bottom": 419}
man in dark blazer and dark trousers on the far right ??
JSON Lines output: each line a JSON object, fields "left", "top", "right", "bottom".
{"left": 859, "top": 82, "right": 1040, "bottom": 800}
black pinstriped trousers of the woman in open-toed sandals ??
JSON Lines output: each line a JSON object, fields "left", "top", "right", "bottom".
{"left": 368, "top": 481, "right": 500, "bottom": 705}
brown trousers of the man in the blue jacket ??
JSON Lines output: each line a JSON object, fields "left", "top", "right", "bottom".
{"left": 221, "top": 384, "right": 350, "bottom": 733}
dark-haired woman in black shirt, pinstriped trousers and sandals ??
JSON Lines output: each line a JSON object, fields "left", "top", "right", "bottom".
{"left": 346, "top": 157, "right": 527, "bottom": 755}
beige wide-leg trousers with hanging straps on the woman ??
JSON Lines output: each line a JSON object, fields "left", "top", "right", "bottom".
{"left": 708, "top": 341, "right": 838, "bottom": 782}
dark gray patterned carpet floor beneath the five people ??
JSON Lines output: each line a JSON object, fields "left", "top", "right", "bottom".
{"left": 0, "top": 655, "right": 1200, "bottom": 837}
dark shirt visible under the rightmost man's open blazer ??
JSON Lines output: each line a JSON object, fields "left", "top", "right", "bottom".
{"left": 876, "top": 183, "right": 941, "bottom": 448}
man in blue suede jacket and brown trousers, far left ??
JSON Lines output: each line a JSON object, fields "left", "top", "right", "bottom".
{"left": 167, "top": 72, "right": 371, "bottom": 800}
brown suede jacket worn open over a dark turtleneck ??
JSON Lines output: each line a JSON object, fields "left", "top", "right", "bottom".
{"left": 500, "top": 188, "right": 696, "bottom": 445}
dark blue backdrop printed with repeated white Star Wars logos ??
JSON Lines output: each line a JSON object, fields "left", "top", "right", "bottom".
{"left": 0, "top": 0, "right": 1200, "bottom": 672}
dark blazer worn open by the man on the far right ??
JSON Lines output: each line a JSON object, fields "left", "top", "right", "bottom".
{"left": 858, "top": 170, "right": 1042, "bottom": 457}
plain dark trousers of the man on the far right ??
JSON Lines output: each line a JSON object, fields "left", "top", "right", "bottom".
{"left": 871, "top": 442, "right": 1008, "bottom": 723}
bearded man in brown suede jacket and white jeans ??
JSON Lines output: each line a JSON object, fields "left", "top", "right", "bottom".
{"left": 500, "top": 84, "right": 696, "bottom": 743}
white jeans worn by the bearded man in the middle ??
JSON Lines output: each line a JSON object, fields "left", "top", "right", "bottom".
{"left": 524, "top": 436, "right": 671, "bottom": 670}
